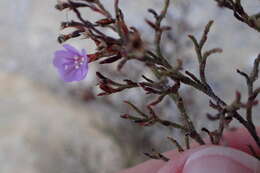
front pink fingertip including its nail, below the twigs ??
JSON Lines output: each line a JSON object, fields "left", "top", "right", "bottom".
{"left": 158, "top": 146, "right": 260, "bottom": 173}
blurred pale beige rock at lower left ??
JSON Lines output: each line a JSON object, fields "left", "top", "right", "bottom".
{"left": 0, "top": 73, "right": 123, "bottom": 173}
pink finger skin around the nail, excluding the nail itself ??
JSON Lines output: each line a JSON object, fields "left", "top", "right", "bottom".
{"left": 119, "top": 127, "right": 260, "bottom": 173}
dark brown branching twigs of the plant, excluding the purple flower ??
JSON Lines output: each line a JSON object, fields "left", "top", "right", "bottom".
{"left": 56, "top": 0, "right": 260, "bottom": 161}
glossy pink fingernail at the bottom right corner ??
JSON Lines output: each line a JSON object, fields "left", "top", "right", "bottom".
{"left": 182, "top": 146, "right": 260, "bottom": 173}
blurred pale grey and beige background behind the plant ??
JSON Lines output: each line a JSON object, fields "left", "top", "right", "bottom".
{"left": 0, "top": 0, "right": 260, "bottom": 173}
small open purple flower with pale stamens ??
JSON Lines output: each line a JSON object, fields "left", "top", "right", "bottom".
{"left": 53, "top": 44, "right": 88, "bottom": 82}
